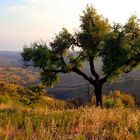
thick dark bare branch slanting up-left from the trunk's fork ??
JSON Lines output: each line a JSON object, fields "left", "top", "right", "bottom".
{"left": 72, "top": 67, "right": 95, "bottom": 85}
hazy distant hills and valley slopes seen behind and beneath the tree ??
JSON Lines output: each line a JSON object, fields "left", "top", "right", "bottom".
{"left": 0, "top": 51, "right": 140, "bottom": 99}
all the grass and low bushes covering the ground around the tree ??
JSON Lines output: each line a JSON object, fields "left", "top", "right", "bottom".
{"left": 0, "top": 83, "right": 140, "bottom": 140}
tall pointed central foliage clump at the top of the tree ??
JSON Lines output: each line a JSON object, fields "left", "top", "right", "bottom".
{"left": 77, "top": 5, "right": 110, "bottom": 57}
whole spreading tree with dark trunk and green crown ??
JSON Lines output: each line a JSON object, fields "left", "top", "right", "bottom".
{"left": 21, "top": 5, "right": 140, "bottom": 106}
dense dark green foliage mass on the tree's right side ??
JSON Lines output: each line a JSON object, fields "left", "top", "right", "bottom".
{"left": 101, "top": 16, "right": 140, "bottom": 79}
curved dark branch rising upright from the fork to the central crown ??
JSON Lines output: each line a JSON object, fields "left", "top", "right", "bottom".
{"left": 89, "top": 56, "right": 100, "bottom": 80}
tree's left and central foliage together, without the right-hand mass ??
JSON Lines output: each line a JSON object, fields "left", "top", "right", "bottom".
{"left": 21, "top": 5, "right": 110, "bottom": 86}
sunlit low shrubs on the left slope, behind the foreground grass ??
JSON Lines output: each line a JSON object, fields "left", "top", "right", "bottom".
{"left": 0, "top": 83, "right": 73, "bottom": 110}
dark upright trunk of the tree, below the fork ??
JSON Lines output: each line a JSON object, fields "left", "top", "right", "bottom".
{"left": 94, "top": 82, "right": 103, "bottom": 107}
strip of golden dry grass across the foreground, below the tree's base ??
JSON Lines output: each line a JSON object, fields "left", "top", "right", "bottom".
{"left": 0, "top": 107, "right": 140, "bottom": 140}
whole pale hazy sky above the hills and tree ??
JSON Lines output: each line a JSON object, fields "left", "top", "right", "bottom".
{"left": 0, "top": 0, "right": 140, "bottom": 51}
